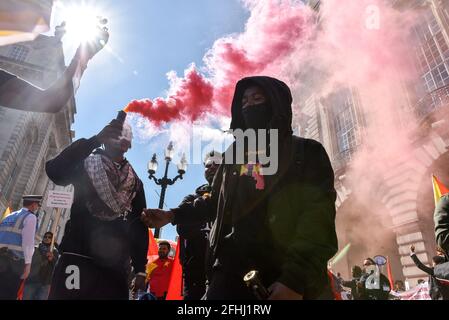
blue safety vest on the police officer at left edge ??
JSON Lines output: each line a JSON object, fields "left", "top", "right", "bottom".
{"left": 0, "top": 208, "right": 33, "bottom": 259}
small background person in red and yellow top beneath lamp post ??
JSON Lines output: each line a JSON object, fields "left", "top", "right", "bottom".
{"left": 147, "top": 241, "right": 173, "bottom": 300}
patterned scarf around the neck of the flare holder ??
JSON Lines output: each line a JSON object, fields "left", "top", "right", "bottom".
{"left": 84, "top": 154, "right": 138, "bottom": 221}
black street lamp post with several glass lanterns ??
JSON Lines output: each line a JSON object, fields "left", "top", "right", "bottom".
{"left": 148, "top": 141, "right": 187, "bottom": 238}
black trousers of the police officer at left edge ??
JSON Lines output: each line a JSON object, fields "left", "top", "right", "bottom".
{"left": 0, "top": 255, "right": 25, "bottom": 300}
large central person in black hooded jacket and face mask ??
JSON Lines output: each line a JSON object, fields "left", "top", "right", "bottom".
{"left": 142, "top": 76, "right": 338, "bottom": 300}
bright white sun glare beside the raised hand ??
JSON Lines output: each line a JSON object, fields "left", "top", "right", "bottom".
{"left": 53, "top": 2, "right": 107, "bottom": 43}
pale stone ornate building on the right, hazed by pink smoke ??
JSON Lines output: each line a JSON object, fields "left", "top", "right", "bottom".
{"left": 295, "top": 0, "right": 449, "bottom": 285}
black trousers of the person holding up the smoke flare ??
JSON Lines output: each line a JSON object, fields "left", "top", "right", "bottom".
{"left": 48, "top": 254, "right": 129, "bottom": 300}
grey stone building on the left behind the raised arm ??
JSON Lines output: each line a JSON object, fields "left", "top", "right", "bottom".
{"left": 0, "top": 32, "right": 76, "bottom": 242}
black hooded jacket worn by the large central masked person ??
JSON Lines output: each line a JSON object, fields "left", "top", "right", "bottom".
{"left": 175, "top": 77, "right": 338, "bottom": 299}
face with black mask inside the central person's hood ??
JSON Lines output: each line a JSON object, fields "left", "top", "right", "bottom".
{"left": 242, "top": 86, "right": 271, "bottom": 129}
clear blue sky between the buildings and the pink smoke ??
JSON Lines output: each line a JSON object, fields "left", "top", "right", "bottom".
{"left": 53, "top": 0, "right": 249, "bottom": 240}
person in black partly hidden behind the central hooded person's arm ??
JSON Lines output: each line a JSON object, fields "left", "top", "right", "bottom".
{"left": 172, "top": 151, "right": 222, "bottom": 300}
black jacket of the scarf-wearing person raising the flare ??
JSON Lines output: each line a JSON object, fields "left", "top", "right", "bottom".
{"left": 45, "top": 136, "right": 148, "bottom": 273}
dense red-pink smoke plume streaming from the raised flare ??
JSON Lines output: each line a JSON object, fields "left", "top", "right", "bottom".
{"left": 125, "top": 0, "right": 313, "bottom": 126}
